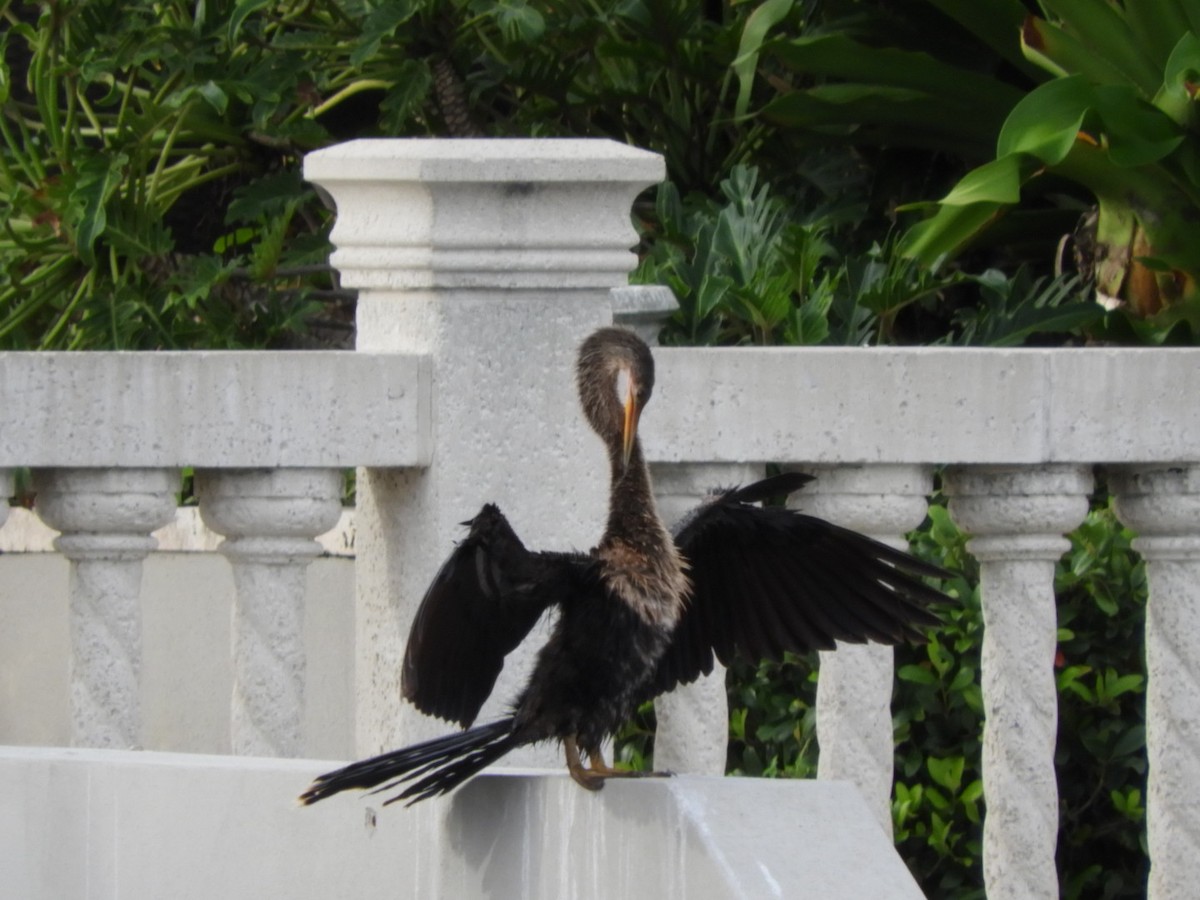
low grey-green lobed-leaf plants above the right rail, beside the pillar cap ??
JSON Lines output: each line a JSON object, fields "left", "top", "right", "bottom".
{"left": 634, "top": 166, "right": 1105, "bottom": 347}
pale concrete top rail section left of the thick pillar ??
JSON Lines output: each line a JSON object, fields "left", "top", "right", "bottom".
{"left": 0, "top": 350, "right": 431, "bottom": 468}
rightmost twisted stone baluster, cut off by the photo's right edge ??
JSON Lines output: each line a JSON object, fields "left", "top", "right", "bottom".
{"left": 1111, "top": 464, "right": 1200, "bottom": 900}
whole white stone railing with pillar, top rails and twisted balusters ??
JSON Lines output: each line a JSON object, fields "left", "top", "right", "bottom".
{"left": 0, "top": 140, "right": 1200, "bottom": 899}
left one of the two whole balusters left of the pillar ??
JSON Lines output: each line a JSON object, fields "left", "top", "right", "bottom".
{"left": 34, "top": 469, "right": 179, "bottom": 749}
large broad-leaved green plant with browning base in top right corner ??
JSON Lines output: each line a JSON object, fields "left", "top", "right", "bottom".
{"left": 905, "top": 0, "right": 1200, "bottom": 321}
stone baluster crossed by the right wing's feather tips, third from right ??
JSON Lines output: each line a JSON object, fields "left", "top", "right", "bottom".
{"left": 791, "top": 466, "right": 934, "bottom": 835}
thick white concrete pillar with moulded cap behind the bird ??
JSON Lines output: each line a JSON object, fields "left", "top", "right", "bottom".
{"left": 305, "top": 139, "right": 664, "bottom": 766}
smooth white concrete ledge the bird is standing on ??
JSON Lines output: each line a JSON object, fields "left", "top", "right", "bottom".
{"left": 0, "top": 748, "right": 922, "bottom": 900}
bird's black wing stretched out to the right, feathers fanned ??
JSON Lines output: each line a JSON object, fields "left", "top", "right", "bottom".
{"left": 652, "top": 473, "right": 948, "bottom": 694}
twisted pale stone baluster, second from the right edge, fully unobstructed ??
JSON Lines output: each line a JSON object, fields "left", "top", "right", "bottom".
{"left": 944, "top": 466, "right": 1092, "bottom": 900}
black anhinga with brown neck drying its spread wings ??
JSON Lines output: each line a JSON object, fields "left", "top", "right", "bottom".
{"left": 301, "top": 328, "right": 946, "bottom": 803}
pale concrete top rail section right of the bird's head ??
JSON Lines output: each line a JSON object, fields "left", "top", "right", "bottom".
{"left": 641, "top": 347, "right": 1200, "bottom": 464}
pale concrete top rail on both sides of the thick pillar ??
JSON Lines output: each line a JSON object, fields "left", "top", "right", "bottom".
{"left": 0, "top": 347, "right": 1200, "bottom": 468}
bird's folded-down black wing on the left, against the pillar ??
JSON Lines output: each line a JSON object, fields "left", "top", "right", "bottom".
{"left": 401, "top": 504, "right": 581, "bottom": 728}
